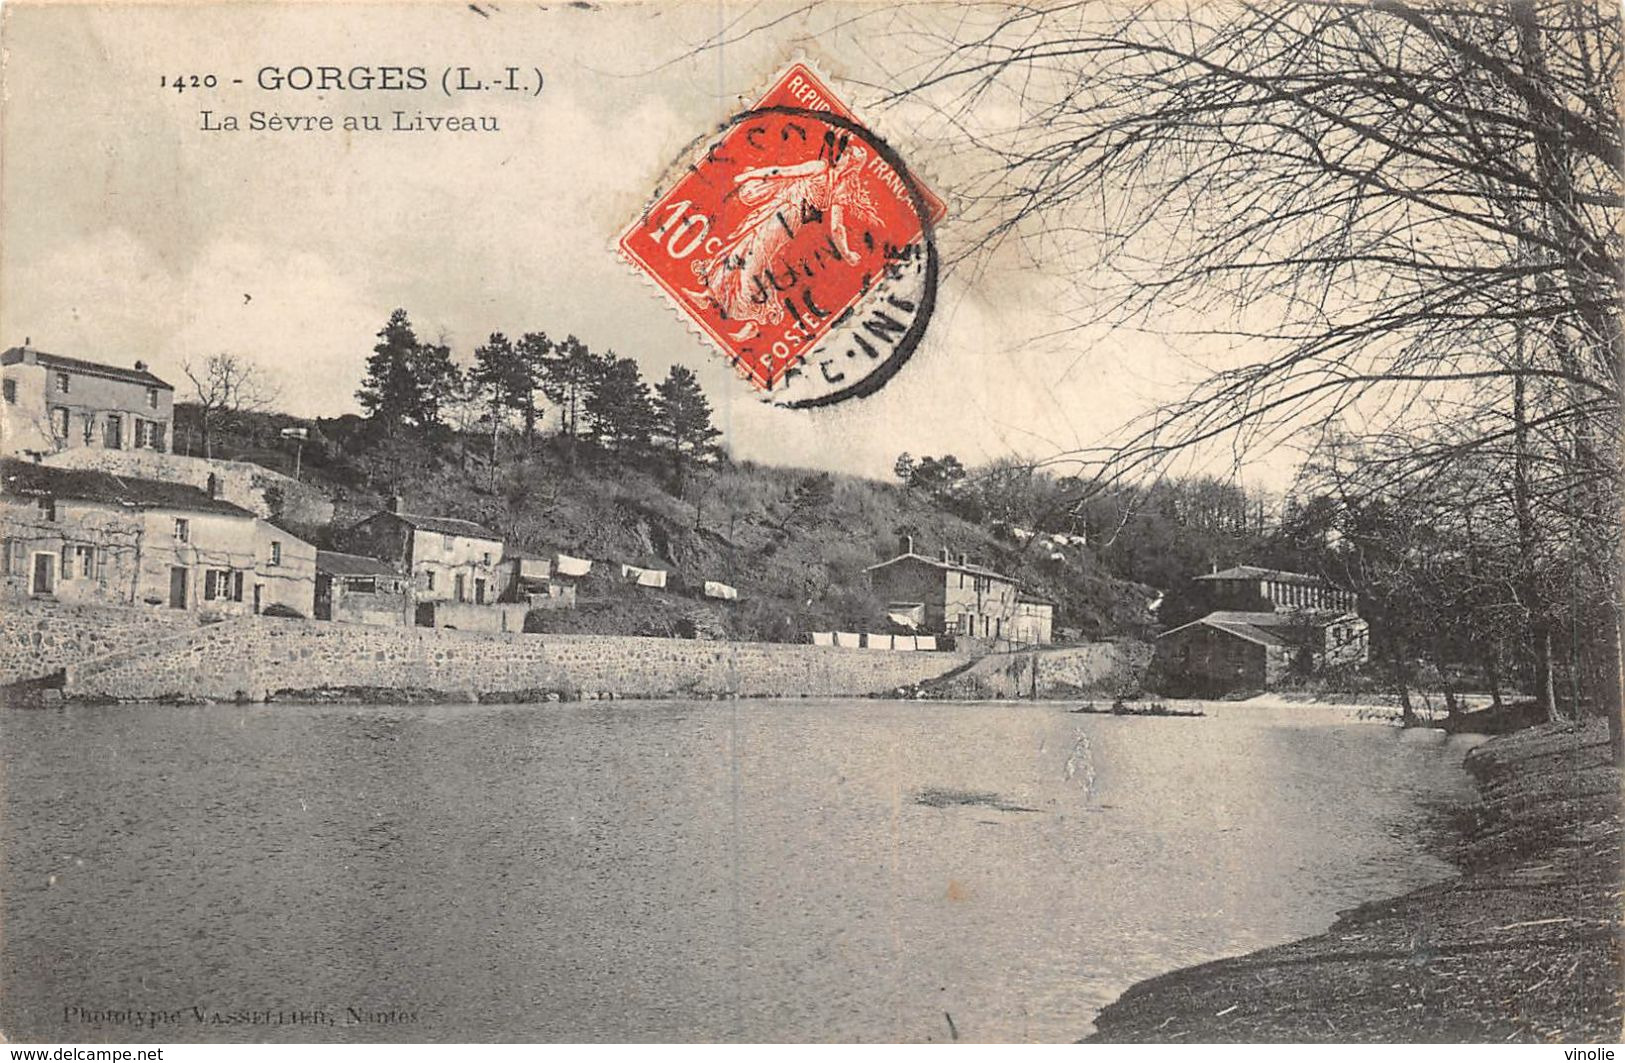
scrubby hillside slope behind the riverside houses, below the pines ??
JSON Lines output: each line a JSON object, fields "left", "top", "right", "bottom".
{"left": 176, "top": 405, "right": 1151, "bottom": 640}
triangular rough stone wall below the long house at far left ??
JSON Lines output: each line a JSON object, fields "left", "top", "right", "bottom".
{"left": 0, "top": 595, "right": 198, "bottom": 683}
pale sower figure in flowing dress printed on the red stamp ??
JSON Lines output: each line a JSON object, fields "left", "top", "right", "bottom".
{"left": 684, "top": 143, "right": 879, "bottom": 340}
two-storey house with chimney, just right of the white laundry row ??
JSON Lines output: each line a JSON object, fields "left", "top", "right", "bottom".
{"left": 866, "top": 536, "right": 1032, "bottom": 644}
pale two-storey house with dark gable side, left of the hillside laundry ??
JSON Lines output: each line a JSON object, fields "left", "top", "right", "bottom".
{"left": 345, "top": 497, "right": 505, "bottom": 605}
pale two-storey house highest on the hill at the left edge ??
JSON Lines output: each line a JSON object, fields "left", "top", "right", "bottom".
{"left": 0, "top": 346, "right": 176, "bottom": 457}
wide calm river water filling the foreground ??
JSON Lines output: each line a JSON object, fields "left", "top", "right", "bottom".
{"left": 0, "top": 701, "right": 1471, "bottom": 1042}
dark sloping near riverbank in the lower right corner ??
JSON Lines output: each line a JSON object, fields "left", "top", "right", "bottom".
{"left": 1087, "top": 723, "right": 1622, "bottom": 1042}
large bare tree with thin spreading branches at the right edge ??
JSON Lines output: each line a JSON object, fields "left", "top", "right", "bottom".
{"left": 858, "top": 0, "right": 1625, "bottom": 757}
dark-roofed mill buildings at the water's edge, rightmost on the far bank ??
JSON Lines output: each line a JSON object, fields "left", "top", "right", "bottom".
{"left": 1155, "top": 566, "right": 1370, "bottom": 692}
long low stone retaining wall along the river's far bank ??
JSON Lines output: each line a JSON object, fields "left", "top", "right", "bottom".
{"left": 68, "top": 618, "right": 967, "bottom": 701}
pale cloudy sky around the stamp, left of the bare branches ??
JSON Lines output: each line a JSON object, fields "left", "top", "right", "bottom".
{"left": 0, "top": 3, "right": 1267, "bottom": 476}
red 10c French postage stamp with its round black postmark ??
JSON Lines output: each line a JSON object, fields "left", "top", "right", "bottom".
{"left": 619, "top": 63, "right": 946, "bottom": 405}
